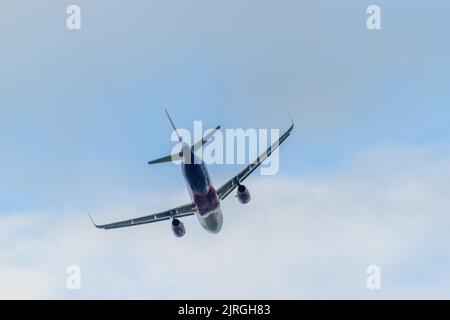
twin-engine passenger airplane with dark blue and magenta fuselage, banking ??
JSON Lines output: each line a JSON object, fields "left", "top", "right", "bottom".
{"left": 88, "top": 110, "right": 294, "bottom": 238}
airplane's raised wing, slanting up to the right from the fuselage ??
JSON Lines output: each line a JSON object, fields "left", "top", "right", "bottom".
{"left": 217, "top": 123, "right": 294, "bottom": 200}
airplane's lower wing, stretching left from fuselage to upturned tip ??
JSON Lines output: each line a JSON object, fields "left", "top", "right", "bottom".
{"left": 89, "top": 202, "right": 197, "bottom": 230}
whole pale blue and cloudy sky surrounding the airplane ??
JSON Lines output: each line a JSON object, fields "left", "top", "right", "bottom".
{"left": 0, "top": 0, "right": 450, "bottom": 299}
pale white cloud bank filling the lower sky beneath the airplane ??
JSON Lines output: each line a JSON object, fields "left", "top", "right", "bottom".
{"left": 0, "top": 147, "right": 450, "bottom": 299}
